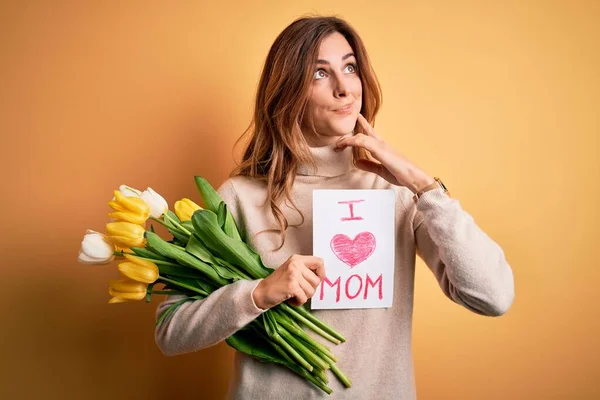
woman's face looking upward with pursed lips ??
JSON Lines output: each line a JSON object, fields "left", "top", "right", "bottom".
{"left": 304, "top": 32, "right": 362, "bottom": 146}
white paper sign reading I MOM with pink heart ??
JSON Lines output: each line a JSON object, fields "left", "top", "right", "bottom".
{"left": 311, "top": 189, "right": 396, "bottom": 309}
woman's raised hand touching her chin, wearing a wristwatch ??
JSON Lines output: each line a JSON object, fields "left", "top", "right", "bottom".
{"left": 335, "top": 114, "right": 434, "bottom": 193}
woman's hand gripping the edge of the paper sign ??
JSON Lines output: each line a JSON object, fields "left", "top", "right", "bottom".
{"left": 252, "top": 254, "right": 325, "bottom": 310}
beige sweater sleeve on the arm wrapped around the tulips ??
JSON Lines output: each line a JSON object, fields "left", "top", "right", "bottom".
{"left": 155, "top": 180, "right": 264, "bottom": 356}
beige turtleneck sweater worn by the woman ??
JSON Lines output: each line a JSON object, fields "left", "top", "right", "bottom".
{"left": 156, "top": 146, "right": 514, "bottom": 400}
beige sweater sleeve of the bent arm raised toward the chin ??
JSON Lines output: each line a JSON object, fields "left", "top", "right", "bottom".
{"left": 413, "top": 189, "right": 514, "bottom": 316}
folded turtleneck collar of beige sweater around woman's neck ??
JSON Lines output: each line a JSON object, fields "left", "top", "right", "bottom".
{"left": 296, "top": 139, "right": 354, "bottom": 177}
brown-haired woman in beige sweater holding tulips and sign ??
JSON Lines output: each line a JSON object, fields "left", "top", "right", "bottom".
{"left": 156, "top": 17, "right": 514, "bottom": 400}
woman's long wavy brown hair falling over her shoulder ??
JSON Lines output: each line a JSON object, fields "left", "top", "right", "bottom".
{"left": 231, "top": 16, "right": 382, "bottom": 250}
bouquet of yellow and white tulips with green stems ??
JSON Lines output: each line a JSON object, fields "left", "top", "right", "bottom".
{"left": 79, "top": 176, "right": 351, "bottom": 394}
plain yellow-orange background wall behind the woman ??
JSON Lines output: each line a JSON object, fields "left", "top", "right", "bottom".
{"left": 0, "top": 0, "right": 600, "bottom": 399}
